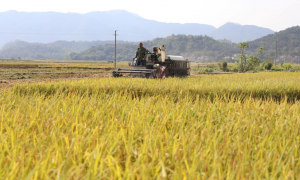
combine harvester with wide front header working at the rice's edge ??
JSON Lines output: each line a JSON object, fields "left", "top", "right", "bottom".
{"left": 113, "top": 45, "right": 191, "bottom": 78}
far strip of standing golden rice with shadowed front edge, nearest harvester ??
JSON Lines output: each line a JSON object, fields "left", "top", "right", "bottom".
{"left": 14, "top": 73, "right": 300, "bottom": 102}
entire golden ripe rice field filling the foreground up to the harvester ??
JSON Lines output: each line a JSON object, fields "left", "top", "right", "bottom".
{"left": 0, "top": 72, "right": 300, "bottom": 179}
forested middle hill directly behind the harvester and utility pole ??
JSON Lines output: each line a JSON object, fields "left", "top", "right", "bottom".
{"left": 70, "top": 35, "right": 239, "bottom": 61}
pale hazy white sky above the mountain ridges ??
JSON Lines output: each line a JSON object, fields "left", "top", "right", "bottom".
{"left": 0, "top": 0, "right": 300, "bottom": 31}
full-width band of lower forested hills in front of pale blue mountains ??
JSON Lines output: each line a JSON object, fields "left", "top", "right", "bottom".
{"left": 0, "top": 26, "right": 300, "bottom": 61}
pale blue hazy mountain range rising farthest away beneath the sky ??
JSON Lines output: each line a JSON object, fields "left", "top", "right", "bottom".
{"left": 0, "top": 10, "right": 274, "bottom": 47}
